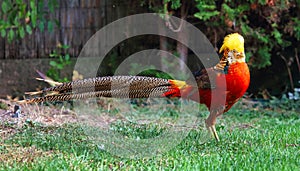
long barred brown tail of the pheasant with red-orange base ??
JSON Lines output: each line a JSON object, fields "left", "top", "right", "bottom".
{"left": 21, "top": 76, "right": 185, "bottom": 103}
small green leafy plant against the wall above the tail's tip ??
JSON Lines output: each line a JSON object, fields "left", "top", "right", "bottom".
{"left": 47, "top": 45, "right": 71, "bottom": 82}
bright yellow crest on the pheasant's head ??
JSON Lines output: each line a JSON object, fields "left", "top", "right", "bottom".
{"left": 219, "top": 33, "right": 244, "bottom": 53}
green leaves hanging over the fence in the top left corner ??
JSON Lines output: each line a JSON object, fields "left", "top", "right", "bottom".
{"left": 0, "top": 0, "right": 58, "bottom": 42}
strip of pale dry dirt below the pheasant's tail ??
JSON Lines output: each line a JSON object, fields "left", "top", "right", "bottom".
{"left": 0, "top": 99, "right": 124, "bottom": 140}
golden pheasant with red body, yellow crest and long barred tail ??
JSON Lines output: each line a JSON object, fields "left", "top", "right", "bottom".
{"left": 23, "top": 33, "right": 250, "bottom": 141}
